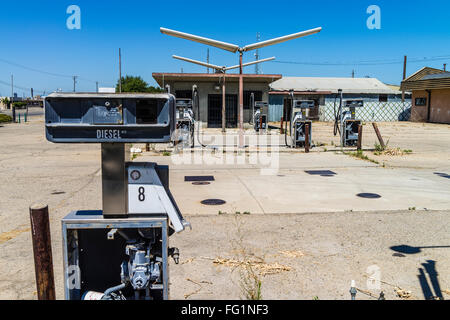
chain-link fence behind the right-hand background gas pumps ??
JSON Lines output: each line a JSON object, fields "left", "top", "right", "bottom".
{"left": 319, "top": 101, "right": 412, "bottom": 122}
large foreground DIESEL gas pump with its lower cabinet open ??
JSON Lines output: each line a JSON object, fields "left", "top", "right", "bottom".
{"left": 44, "top": 93, "right": 190, "bottom": 300}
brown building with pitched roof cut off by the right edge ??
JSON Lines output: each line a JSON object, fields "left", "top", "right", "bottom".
{"left": 402, "top": 67, "right": 450, "bottom": 124}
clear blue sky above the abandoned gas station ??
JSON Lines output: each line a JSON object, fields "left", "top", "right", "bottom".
{"left": 0, "top": 0, "right": 450, "bottom": 96}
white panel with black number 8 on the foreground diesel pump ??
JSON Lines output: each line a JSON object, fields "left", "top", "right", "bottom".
{"left": 128, "top": 184, "right": 166, "bottom": 214}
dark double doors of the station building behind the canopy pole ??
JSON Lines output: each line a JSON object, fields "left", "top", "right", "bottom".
{"left": 208, "top": 94, "right": 238, "bottom": 128}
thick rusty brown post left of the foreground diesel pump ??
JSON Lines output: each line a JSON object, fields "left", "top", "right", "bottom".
{"left": 30, "top": 205, "right": 56, "bottom": 300}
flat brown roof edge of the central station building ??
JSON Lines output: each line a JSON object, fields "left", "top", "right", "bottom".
{"left": 153, "top": 72, "right": 282, "bottom": 87}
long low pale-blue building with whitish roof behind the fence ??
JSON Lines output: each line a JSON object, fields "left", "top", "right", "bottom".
{"left": 269, "top": 77, "right": 410, "bottom": 121}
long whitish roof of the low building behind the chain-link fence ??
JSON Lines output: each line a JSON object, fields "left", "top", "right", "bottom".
{"left": 270, "top": 77, "right": 397, "bottom": 94}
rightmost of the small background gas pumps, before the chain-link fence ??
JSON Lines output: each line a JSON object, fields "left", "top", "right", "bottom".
{"left": 334, "top": 90, "right": 364, "bottom": 147}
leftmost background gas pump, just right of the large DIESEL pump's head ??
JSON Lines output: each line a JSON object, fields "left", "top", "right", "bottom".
{"left": 176, "top": 99, "right": 195, "bottom": 148}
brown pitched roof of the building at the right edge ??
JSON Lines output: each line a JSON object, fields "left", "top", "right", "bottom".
{"left": 402, "top": 67, "right": 450, "bottom": 91}
